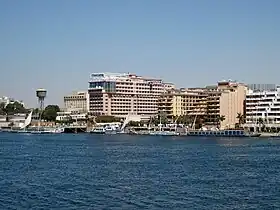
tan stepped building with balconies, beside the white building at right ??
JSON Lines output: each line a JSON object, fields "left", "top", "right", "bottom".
{"left": 159, "top": 81, "right": 247, "bottom": 128}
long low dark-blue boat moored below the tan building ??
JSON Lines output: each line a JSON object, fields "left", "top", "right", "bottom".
{"left": 186, "top": 130, "right": 261, "bottom": 137}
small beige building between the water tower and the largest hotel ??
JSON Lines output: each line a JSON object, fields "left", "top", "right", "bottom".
{"left": 64, "top": 91, "right": 89, "bottom": 113}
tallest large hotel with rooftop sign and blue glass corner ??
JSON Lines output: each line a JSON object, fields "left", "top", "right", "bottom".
{"left": 88, "top": 73, "right": 175, "bottom": 119}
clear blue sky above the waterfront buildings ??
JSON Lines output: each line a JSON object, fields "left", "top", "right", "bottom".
{"left": 0, "top": 0, "right": 280, "bottom": 106}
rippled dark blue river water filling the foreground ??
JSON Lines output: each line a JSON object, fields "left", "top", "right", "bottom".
{"left": 0, "top": 133, "right": 280, "bottom": 210}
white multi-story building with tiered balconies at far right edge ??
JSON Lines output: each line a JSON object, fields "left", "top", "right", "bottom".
{"left": 246, "top": 87, "right": 280, "bottom": 124}
